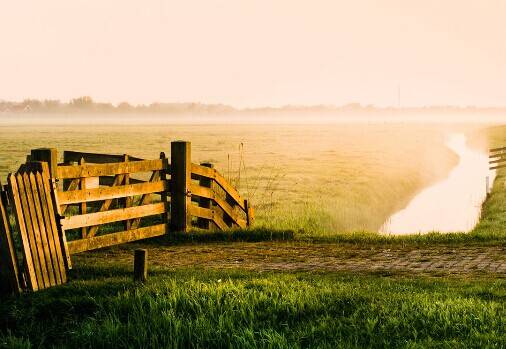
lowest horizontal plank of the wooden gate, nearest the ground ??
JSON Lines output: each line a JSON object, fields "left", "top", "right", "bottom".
{"left": 69, "top": 224, "right": 167, "bottom": 254}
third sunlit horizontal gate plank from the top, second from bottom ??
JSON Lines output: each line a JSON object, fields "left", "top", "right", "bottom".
{"left": 62, "top": 202, "right": 165, "bottom": 230}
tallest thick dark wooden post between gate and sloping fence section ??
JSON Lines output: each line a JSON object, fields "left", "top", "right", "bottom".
{"left": 170, "top": 141, "right": 191, "bottom": 232}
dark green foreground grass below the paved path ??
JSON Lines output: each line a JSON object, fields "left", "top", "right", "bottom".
{"left": 0, "top": 266, "right": 506, "bottom": 348}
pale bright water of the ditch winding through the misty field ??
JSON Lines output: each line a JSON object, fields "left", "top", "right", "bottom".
{"left": 380, "top": 134, "right": 495, "bottom": 234}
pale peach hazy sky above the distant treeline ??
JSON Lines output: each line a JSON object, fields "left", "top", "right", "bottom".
{"left": 0, "top": 0, "right": 506, "bottom": 107}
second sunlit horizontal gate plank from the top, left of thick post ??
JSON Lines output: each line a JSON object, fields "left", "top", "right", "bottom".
{"left": 58, "top": 181, "right": 170, "bottom": 205}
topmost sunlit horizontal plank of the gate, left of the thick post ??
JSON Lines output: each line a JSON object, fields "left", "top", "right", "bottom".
{"left": 58, "top": 159, "right": 169, "bottom": 179}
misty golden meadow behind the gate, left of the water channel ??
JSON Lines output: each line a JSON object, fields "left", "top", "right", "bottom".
{"left": 0, "top": 122, "right": 469, "bottom": 237}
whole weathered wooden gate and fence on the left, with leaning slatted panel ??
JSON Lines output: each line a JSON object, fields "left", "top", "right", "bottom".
{"left": 0, "top": 141, "right": 254, "bottom": 290}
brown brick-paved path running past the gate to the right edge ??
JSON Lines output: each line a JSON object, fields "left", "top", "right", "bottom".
{"left": 73, "top": 242, "right": 506, "bottom": 277}
